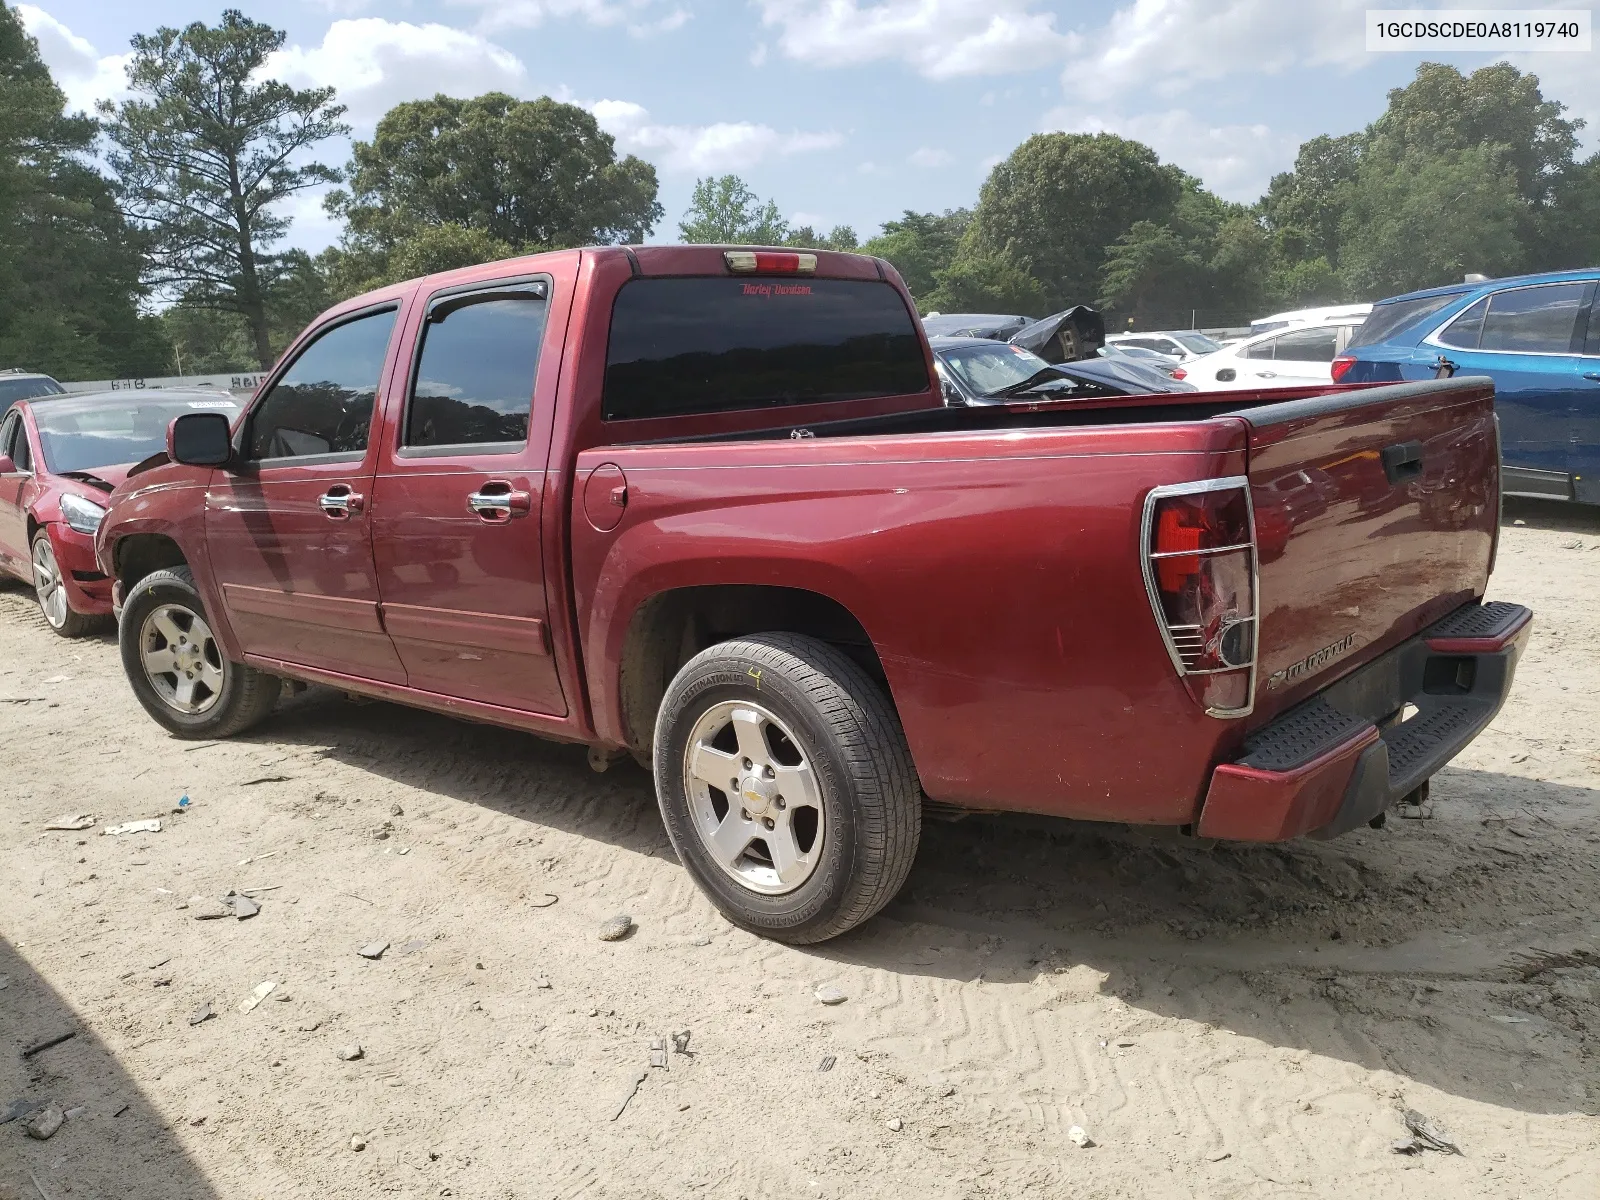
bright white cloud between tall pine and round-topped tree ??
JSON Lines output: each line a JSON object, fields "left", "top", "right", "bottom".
{"left": 264, "top": 16, "right": 528, "bottom": 133}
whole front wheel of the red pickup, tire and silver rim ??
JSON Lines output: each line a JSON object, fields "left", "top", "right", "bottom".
{"left": 118, "top": 566, "right": 283, "bottom": 738}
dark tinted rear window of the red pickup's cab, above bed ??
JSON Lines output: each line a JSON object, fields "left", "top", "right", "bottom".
{"left": 602, "top": 278, "right": 930, "bottom": 421}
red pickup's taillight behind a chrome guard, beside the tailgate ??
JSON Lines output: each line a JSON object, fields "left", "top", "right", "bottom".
{"left": 1144, "top": 475, "right": 1258, "bottom": 717}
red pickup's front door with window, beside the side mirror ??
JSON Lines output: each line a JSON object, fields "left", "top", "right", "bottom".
{"left": 206, "top": 306, "right": 405, "bottom": 683}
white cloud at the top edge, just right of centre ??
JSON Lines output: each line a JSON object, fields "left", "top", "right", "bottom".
{"left": 758, "top": 0, "right": 1078, "bottom": 80}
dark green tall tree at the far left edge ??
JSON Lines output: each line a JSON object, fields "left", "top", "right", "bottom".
{"left": 0, "top": 5, "right": 166, "bottom": 379}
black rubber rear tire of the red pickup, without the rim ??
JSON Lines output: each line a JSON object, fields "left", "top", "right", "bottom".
{"left": 654, "top": 634, "right": 922, "bottom": 944}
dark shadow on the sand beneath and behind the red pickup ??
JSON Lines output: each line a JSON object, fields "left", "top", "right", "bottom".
{"left": 256, "top": 691, "right": 1600, "bottom": 1114}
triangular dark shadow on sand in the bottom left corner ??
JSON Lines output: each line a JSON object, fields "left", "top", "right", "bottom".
{"left": 0, "top": 938, "right": 227, "bottom": 1200}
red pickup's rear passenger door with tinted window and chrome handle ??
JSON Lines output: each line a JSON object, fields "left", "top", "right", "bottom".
{"left": 373, "top": 277, "right": 566, "bottom": 717}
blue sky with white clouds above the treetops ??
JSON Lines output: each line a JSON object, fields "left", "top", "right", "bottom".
{"left": 19, "top": 0, "right": 1600, "bottom": 250}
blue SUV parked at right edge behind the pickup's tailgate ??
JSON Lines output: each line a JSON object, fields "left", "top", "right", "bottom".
{"left": 1333, "top": 267, "right": 1600, "bottom": 504}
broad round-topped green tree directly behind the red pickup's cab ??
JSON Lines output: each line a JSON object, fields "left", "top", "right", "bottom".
{"left": 328, "top": 91, "right": 661, "bottom": 280}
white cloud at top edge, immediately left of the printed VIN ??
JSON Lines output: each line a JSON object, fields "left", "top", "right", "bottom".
{"left": 1062, "top": 0, "right": 1371, "bottom": 96}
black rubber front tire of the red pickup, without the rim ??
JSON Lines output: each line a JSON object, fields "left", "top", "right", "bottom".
{"left": 118, "top": 566, "right": 283, "bottom": 739}
